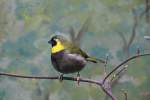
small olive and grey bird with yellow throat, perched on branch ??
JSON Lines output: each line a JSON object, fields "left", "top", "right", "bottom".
{"left": 48, "top": 35, "right": 104, "bottom": 80}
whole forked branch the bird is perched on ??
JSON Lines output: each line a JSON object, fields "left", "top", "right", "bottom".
{"left": 0, "top": 53, "right": 150, "bottom": 100}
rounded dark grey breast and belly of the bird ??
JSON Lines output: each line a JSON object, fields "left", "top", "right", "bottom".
{"left": 51, "top": 51, "right": 86, "bottom": 73}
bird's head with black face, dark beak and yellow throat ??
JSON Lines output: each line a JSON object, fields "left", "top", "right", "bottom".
{"left": 48, "top": 35, "right": 67, "bottom": 53}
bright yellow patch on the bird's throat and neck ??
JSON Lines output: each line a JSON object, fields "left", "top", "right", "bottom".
{"left": 51, "top": 39, "right": 65, "bottom": 53}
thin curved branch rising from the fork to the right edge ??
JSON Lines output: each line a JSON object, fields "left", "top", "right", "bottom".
{"left": 103, "top": 53, "right": 150, "bottom": 84}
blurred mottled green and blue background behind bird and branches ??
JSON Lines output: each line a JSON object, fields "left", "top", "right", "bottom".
{"left": 0, "top": 0, "right": 150, "bottom": 100}
